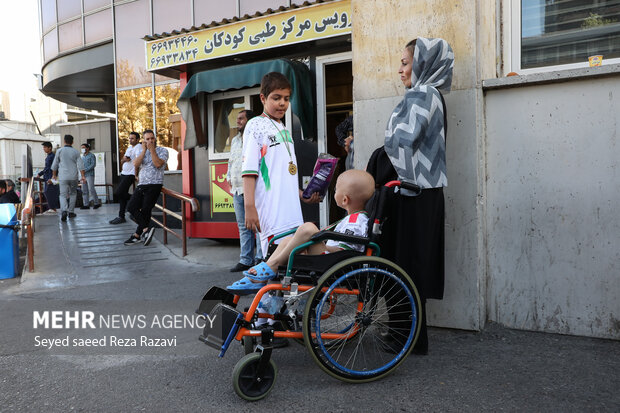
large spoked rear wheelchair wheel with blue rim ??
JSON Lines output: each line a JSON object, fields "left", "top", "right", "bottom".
{"left": 303, "top": 257, "right": 421, "bottom": 383}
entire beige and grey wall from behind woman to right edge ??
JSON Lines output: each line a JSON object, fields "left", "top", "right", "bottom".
{"left": 352, "top": 0, "right": 620, "bottom": 339}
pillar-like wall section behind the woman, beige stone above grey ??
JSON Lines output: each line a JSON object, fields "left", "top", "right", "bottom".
{"left": 352, "top": 0, "right": 495, "bottom": 330}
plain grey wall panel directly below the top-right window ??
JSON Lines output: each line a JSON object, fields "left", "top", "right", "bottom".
{"left": 485, "top": 73, "right": 620, "bottom": 339}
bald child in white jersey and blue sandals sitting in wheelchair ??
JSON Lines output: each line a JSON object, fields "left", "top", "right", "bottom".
{"left": 226, "top": 169, "right": 375, "bottom": 295}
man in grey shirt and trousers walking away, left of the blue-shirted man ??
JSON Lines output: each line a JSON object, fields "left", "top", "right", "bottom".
{"left": 52, "top": 135, "right": 86, "bottom": 221}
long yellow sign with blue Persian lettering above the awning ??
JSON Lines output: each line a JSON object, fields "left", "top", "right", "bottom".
{"left": 146, "top": 0, "right": 351, "bottom": 70}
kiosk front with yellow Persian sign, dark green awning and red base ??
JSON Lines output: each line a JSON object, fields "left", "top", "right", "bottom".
{"left": 145, "top": 0, "right": 353, "bottom": 238}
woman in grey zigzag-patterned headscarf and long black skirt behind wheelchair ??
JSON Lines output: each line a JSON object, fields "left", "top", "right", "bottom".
{"left": 367, "top": 37, "right": 454, "bottom": 354}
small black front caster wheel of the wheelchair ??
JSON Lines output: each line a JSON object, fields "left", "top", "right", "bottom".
{"left": 233, "top": 353, "right": 278, "bottom": 401}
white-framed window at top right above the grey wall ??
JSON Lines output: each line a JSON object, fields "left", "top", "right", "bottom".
{"left": 510, "top": 0, "right": 620, "bottom": 74}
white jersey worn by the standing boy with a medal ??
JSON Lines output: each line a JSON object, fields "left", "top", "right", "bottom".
{"left": 241, "top": 116, "right": 303, "bottom": 253}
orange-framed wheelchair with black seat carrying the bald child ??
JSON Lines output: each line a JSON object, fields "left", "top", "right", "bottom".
{"left": 196, "top": 181, "right": 422, "bottom": 401}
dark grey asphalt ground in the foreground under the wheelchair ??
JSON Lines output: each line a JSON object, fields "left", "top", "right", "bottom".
{"left": 0, "top": 211, "right": 620, "bottom": 412}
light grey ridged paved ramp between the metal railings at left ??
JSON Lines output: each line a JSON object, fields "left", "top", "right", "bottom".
{"left": 9, "top": 204, "right": 238, "bottom": 291}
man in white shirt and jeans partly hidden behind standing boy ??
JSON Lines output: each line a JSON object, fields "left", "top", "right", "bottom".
{"left": 226, "top": 109, "right": 262, "bottom": 272}
